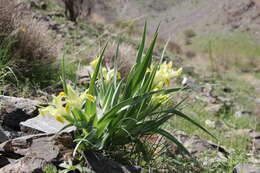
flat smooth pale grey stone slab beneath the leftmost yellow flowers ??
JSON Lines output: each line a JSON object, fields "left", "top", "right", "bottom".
{"left": 20, "top": 115, "right": 76, "bottom": 134}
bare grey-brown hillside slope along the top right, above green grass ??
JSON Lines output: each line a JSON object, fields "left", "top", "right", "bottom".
{"left": 90, "top": 0, "right": 260, "bottom": 38}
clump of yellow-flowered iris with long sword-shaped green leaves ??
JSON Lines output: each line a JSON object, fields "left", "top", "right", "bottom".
{"left": 40, "top": 26, "right": 213, "bottom": 161}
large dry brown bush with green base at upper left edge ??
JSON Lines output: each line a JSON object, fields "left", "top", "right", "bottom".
{"left": 0, "top": 1, "right": 59, "bottom": 92}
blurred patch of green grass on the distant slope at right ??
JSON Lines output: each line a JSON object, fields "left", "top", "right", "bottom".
{"left": 193, "top": 32, "right": 260, "bottom": 71}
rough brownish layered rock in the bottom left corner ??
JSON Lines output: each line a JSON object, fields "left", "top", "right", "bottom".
{"left": 0, "top": 133, "right": 73, "bottom": 173}
